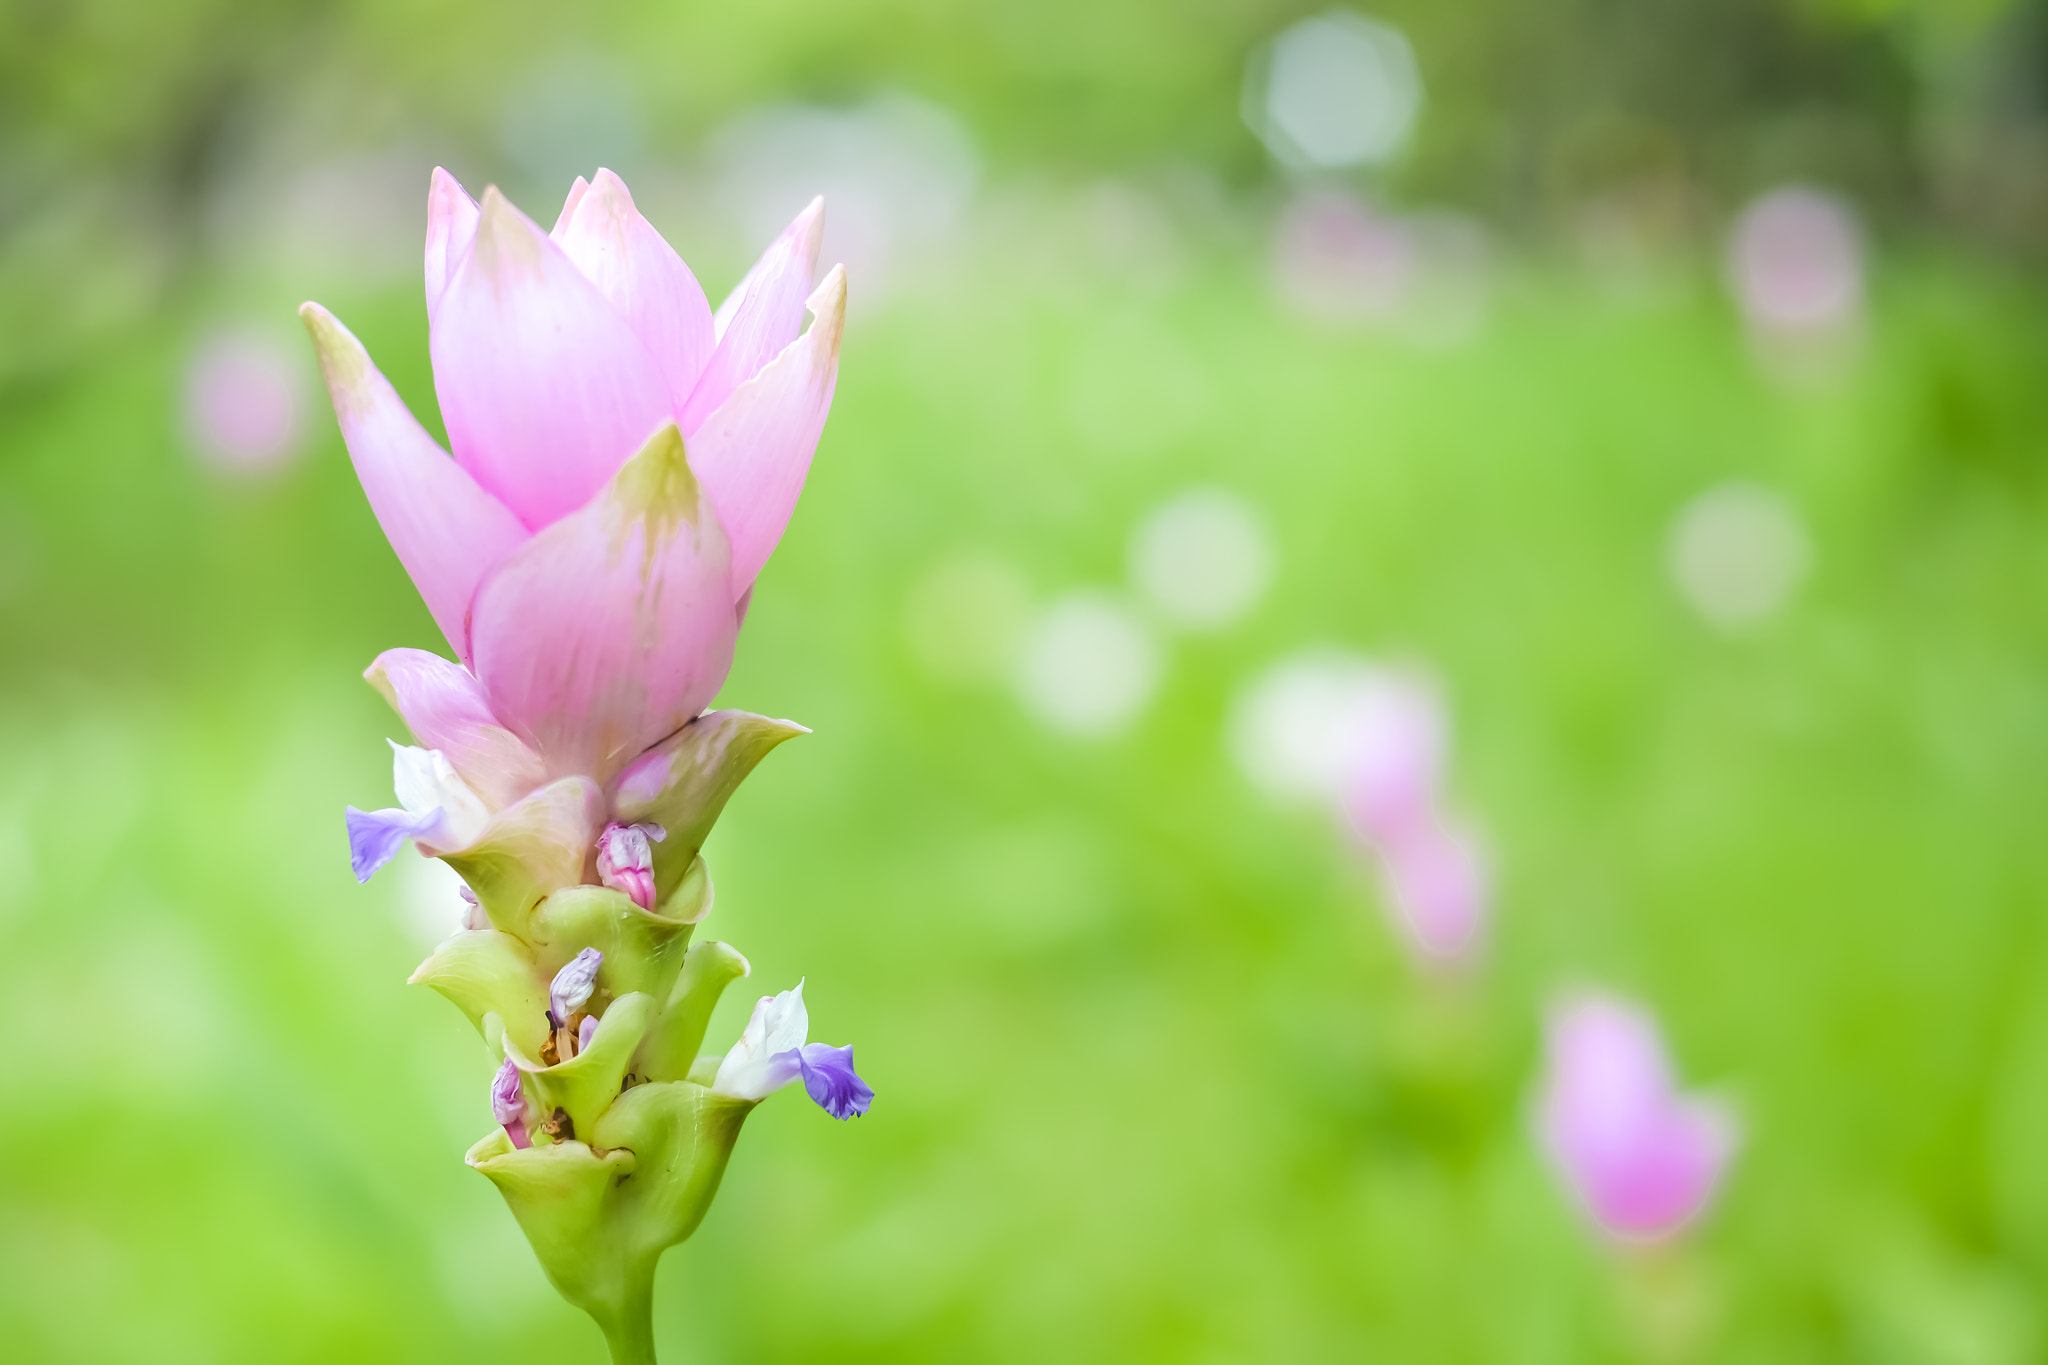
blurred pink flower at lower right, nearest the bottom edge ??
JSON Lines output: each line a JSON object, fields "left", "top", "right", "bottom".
{"left": 1538, "top": 997, "right": 1735, "bottom": 1242}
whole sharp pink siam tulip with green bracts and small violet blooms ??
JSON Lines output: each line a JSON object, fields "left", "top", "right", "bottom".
{"left": 301, "top": 170, "right": 872, "bottom": 1365}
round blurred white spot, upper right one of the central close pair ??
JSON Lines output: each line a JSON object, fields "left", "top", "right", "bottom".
{"left": 1130, "top": 489, "right": 1274, "bottom": 630}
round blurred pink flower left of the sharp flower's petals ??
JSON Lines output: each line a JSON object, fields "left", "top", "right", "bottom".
{"left": 184, "top": 332, "right": 305, "bottom": 473}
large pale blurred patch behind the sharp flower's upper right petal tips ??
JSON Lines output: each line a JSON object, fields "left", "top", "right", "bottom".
{"left": 711, "top": 94, "right": 981, "bottom": 307}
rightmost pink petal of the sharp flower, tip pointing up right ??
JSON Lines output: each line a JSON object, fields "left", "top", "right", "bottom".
{"left": 690, "top": 266, "right": 846, "bottom": 598}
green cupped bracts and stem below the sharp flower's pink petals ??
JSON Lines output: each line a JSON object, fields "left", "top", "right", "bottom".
{"left": 412, "top": 710, "right": 807, "bottom": 1361}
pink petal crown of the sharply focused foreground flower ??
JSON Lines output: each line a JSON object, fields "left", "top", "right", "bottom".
{"left": 299, "top": 170, "right": 846, "bottom": 810}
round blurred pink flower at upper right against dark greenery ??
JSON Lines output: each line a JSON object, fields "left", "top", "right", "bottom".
{"left": 1729, "top": 186, "right": 1864, "bottom": 336}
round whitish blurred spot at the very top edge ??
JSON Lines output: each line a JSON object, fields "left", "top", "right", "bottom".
{"left": 1243, "top": 8, "right": 1423, "bottom": 170}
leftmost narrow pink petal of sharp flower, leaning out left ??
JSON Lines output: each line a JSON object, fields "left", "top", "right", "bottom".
{"left": 299, "top": 303, "right": 526, "bottom": 659}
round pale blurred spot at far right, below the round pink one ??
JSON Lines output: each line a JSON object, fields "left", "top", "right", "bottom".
{"left": 1669, "top": 483, "right": 1812, "bottom": 630}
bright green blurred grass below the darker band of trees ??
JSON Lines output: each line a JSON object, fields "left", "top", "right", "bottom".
{"left": 12, "top": 205, "right": 2048, "bottom": 1365}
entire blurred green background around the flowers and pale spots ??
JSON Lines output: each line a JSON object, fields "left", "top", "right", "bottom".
{"left": 0, "top": 0, "right": 2048, "bottom": 1365}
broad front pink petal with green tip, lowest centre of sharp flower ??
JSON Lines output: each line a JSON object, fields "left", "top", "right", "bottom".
{"left": 473, "top": 422, "right": 737, "bottom": 782}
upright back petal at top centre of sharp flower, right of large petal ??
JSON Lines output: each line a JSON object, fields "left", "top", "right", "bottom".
{"left": 553, "top": 170, "right": 715, "bottom": 411}
